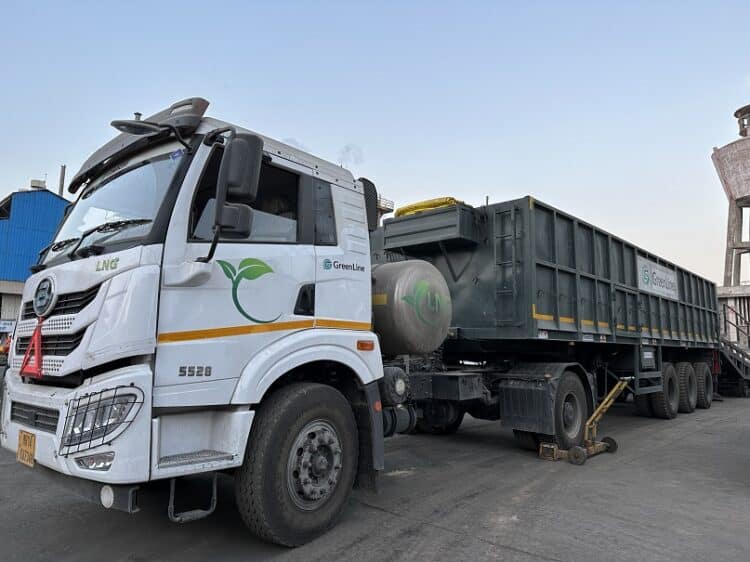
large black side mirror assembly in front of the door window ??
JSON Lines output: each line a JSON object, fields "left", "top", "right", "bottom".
{"left": 198, "top": 133, "right": 263, "bottom": 262}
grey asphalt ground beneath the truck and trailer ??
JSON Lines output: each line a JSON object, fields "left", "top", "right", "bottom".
{"left": 0, "top": 399, "right": 750, "bottom": 562}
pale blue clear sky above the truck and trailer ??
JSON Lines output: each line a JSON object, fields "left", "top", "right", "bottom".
{"left": 0, "top": 0, "right": 750, "bottom": 282}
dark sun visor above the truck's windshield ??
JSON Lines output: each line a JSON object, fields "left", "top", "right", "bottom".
{"left": 68, "top": 98, "right": 208, "bottom": 193}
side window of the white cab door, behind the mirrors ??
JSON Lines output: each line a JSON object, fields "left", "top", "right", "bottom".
{"left": 190, "top": 148, "right": 300, "bottom": 244}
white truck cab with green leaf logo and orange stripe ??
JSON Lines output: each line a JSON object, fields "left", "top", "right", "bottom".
{"left": 0, "top": 98, "right": 406, "bottom": 545}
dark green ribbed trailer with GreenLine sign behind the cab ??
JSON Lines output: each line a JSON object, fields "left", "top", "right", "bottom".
{"left": 372, "top": 197, "right": 736, "bottom": 445}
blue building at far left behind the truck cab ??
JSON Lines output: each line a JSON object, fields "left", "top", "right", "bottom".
{"left": 0, "top": 186, "right": 68, "bottom": 335}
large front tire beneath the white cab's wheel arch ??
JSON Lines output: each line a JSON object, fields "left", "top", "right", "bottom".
{"left": 235, "top": 383, "right": 359, "bottom": 546}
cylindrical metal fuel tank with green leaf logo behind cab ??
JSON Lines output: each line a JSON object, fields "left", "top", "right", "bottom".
{"left": 372, "top": 260, "right": 452, "bottom": 355}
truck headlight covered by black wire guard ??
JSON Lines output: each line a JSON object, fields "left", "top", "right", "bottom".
{"left": 60, "top": 386, "right": 143, "bottom": 455}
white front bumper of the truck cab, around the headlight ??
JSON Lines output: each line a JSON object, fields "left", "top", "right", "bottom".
{"left": 0, "top": 365, "right": 153, "bottom": 484}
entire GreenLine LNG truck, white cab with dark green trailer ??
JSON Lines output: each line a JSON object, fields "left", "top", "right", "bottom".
{"left": 0, "top": 98, "right": 744, "bottom": 546}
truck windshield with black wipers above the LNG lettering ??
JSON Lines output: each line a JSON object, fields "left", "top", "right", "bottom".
{"left": 42, "top": 150, "right": 184, "bottom": 263}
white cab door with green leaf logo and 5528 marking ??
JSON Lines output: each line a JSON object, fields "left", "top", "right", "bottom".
{"left": 154, "top": 146, "right": 315, "bottom": 407}
